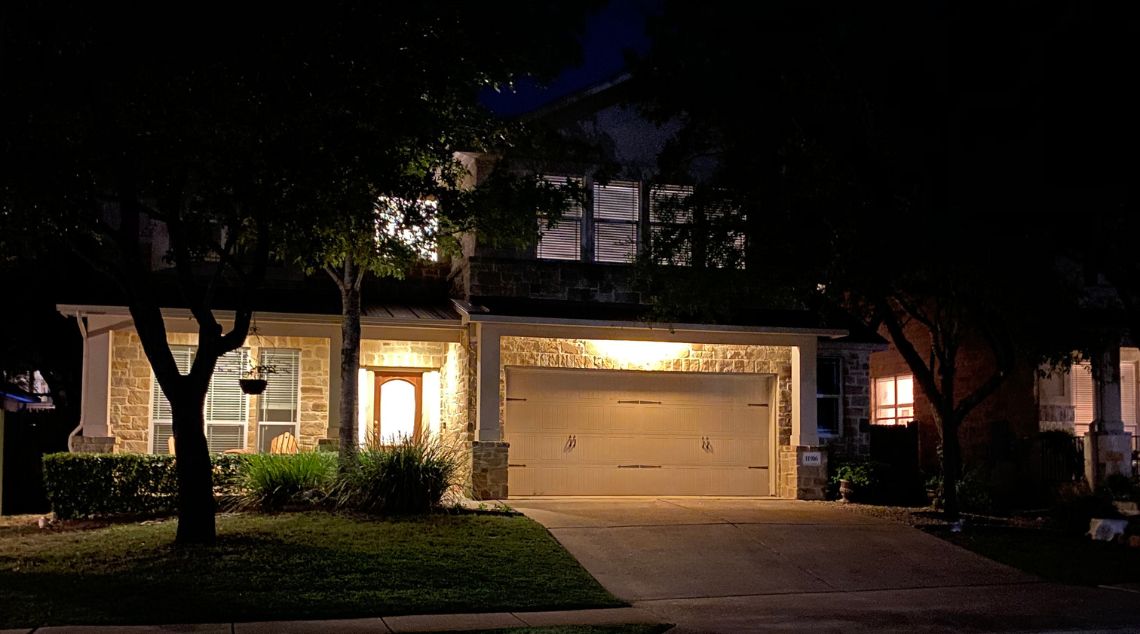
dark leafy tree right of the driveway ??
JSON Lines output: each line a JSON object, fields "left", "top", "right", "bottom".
{"left": 636, "top": 2, "right": 1073, "bottom": 518}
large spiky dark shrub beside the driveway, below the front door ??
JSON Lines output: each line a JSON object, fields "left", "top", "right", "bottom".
{"left": 334, "top": 437, "right": 459, "bottom": 513}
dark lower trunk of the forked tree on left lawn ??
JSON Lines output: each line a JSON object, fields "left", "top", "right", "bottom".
{"left": 168, "top": 396, "right": 217, "bottom": 544}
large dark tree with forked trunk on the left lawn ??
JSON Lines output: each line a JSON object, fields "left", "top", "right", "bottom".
{"left": 0, "top": 2, "right": 597, "bottom": 543}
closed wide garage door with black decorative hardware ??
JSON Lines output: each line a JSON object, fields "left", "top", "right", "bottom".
{"left": 505, "top": 368, "right": 772, "bottom": 495}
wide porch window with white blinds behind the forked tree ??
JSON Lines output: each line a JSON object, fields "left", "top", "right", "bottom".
{"left": 150, "top": 346, "right": 250, "bottom": 454}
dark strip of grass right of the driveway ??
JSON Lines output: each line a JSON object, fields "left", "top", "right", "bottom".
{"left": 927, "top": 526, "right": 1140, "bottom": 586}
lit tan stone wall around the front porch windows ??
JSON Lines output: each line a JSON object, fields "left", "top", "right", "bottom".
{"left": 107, "top": 330, "right": 328, "bottom": 453}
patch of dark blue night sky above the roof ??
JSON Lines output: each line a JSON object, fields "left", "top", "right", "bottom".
{"left": 482, "top": 0, "right": 661, "bottom": 116}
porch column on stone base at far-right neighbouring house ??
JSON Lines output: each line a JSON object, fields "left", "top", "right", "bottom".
{"left": 1084, "top": 344, "right": 1132, "bottom": 488}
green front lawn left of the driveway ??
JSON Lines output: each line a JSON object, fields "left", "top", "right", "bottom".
{"left": 0, "top": 512, "right": 624, "bottom": 628}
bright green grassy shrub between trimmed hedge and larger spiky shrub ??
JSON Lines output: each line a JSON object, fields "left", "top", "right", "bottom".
{"left": 241, "top": 452, "right": 336, "bottom": 511}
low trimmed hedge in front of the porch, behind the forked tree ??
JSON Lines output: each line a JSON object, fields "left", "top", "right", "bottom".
{"left": 43, "top": 453, "right": 246, "bottom": 520}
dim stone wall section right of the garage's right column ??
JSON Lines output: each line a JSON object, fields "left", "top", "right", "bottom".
{"left": 819, "top": 341, "right": 876, "bottom": 461}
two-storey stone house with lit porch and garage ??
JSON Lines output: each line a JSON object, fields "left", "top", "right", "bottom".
{"left": 58, "top": 78, "right": 882, "bottom": 499}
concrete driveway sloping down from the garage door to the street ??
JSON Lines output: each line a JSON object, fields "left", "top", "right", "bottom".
{"left": 511, "top": 498, "right": 1140, "bottom": 632}
